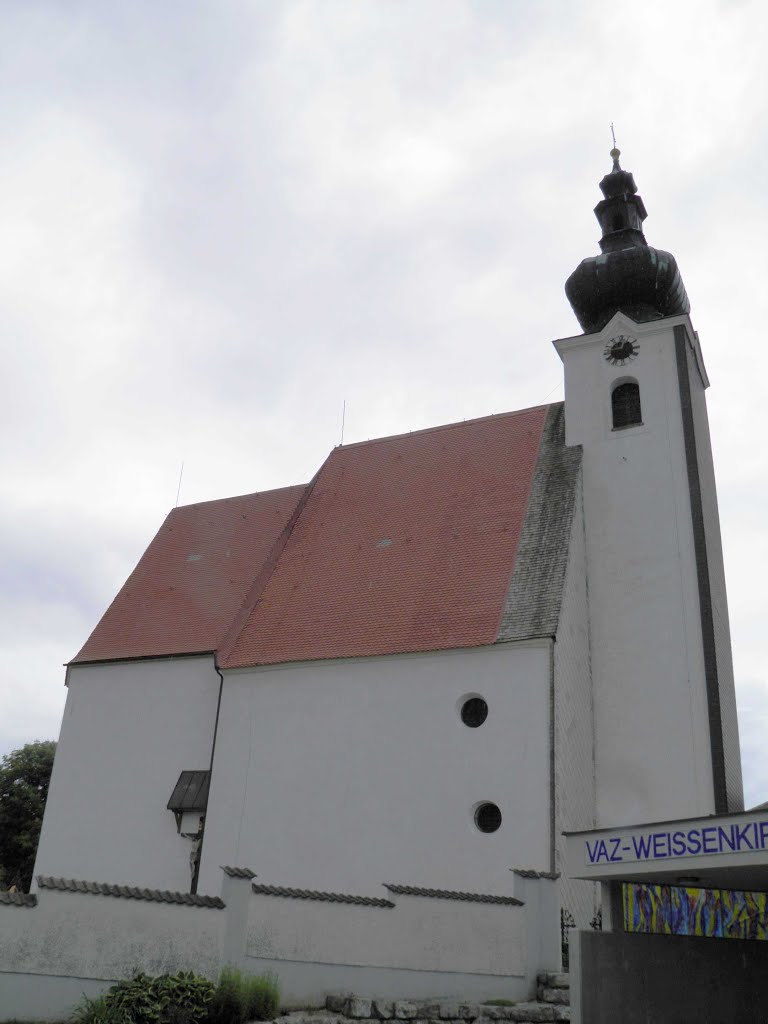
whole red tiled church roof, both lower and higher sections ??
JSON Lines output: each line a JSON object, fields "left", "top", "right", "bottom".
{"left": 74, "top": 406, "right": 561, "bottom": 668}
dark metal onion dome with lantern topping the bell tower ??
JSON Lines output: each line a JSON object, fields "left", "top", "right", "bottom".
{"left": 565, "top": 148, "right": 690, "bottom": 334}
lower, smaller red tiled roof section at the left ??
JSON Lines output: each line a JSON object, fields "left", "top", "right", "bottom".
{"left": 74, "top": 484, "right": 306, "bottom": 662}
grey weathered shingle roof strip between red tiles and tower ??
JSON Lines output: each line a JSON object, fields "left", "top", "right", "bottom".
{"left": 497, "top": 401, "right": 582, "bottom": 643}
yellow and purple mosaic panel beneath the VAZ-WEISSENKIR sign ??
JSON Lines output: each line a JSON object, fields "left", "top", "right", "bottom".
{"left": 623, "top": 883, "right": 768, "bottom": 940}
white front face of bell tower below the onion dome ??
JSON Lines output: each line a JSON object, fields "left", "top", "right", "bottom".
{"left": 556, "top": 314, "right": 714, "bottom": 825}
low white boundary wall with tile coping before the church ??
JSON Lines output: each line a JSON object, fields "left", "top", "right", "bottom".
{"left": 0, "top": 877, "right": 558, "bottom": 1020}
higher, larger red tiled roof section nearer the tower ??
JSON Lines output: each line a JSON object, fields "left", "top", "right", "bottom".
{"left": 219, "top": 407, "right": 548, "bottom": 668}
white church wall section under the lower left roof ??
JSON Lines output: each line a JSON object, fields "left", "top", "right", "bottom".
{"left": 35, "top": 656, "right": 219, "bottom": 892}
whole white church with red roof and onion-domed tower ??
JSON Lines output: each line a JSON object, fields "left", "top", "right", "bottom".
{"left": 35, "top": 150, "right": 743, "bottom": 983}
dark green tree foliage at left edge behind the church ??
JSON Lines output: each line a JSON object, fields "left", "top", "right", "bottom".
{"left": 0, "top": 739, "right": 56, "bottom": 892}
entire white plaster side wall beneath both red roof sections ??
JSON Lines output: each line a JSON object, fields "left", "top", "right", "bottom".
{"left": 35, "top": 641, "right": 553, "bottom": 894}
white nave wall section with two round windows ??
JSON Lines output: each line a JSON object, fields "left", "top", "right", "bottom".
{"left": 201, "top": 644, "right": 550, "bottom": 895}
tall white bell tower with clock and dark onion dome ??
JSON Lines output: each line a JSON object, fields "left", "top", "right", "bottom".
{"left": 555, "top": 148, "right": 743, "bottom": 827}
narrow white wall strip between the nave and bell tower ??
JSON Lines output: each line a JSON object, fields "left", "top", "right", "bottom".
{"left": 554, "top": 481, "right": 597, "bottom": 928}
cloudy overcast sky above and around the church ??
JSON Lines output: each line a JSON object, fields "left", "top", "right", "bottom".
{"left": 0, "top": 0, "right": 768, "bottom": 806}
